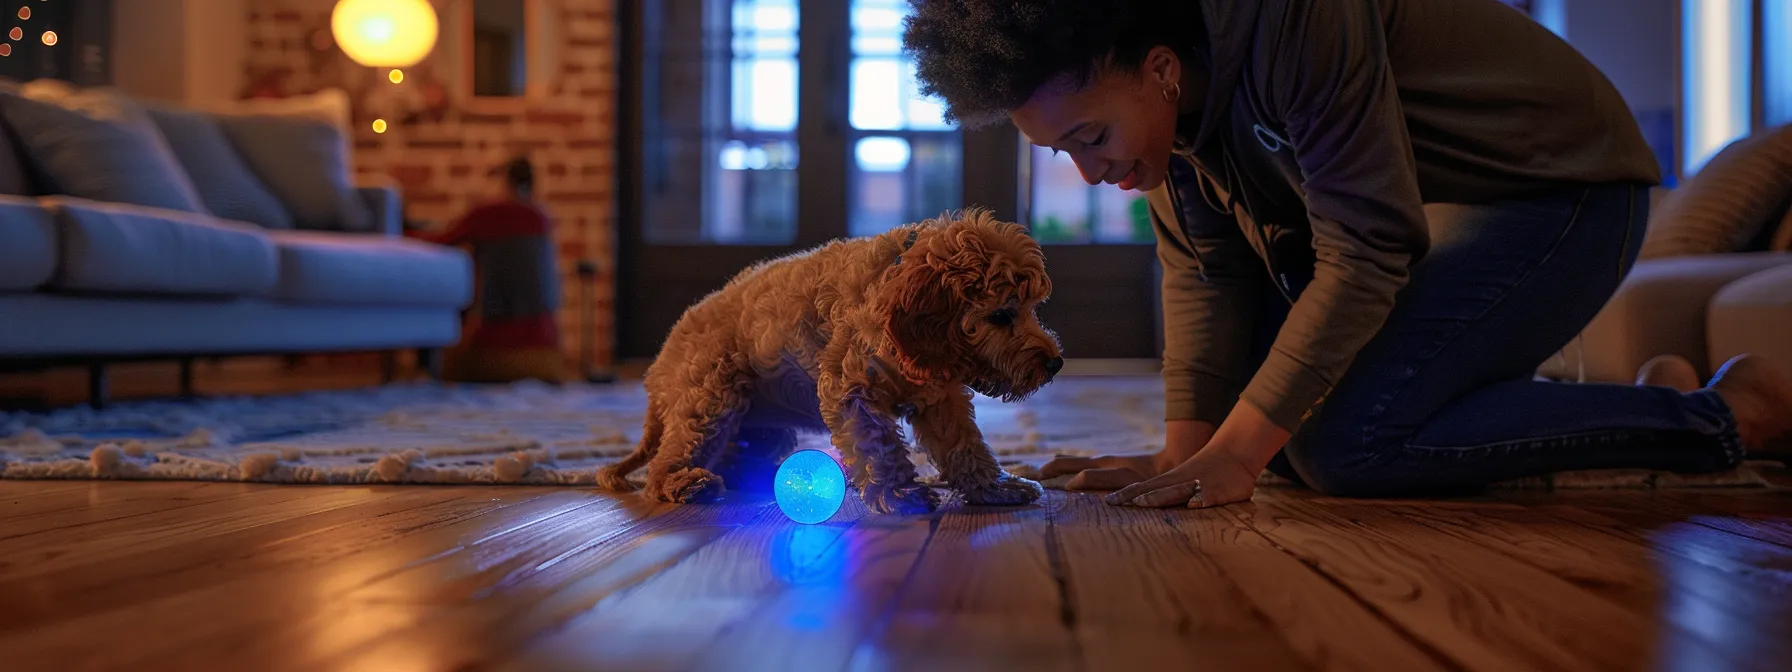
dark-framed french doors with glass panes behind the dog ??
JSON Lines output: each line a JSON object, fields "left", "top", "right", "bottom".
{"left": 616, "top": 0, "right": 1159, "bottom": 360}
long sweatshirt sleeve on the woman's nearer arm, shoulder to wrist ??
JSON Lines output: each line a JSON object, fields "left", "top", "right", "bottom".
{"left": 1242, "top": 0, "right": 1430, "bottom": 432}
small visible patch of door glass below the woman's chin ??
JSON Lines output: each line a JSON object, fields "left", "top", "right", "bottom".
{"left": 1021, "top": 140, "right": 1156, "bottom": 244}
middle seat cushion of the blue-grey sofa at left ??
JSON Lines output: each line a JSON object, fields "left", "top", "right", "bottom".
{"left": 43, "top": 197, "right": 280, "bottom": 296}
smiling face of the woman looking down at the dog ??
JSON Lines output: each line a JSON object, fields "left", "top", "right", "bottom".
{"left": 1009, "top": 47, "right": 1192, "bottom": 192}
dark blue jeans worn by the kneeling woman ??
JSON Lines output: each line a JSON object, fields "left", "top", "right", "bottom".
{"left": 1258, "top": 185, "right": 1744, "bottom": 496}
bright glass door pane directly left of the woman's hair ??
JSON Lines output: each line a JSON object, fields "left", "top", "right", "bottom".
{"left": 848, "top": 0, "right": 964, "bottom": 237}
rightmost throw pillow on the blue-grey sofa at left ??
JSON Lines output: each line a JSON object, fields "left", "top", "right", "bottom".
{"left": 219, "top": 115, "right": 375, "bottom": 233}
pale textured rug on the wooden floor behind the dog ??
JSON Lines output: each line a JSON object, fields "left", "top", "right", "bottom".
{"left": 0, "top": 376, "right": 1767, "bottom": 489}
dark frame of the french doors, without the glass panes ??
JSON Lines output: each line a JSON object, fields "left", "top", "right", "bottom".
{"left": 613, "top": 0, "right": 1161, "bottom": 360}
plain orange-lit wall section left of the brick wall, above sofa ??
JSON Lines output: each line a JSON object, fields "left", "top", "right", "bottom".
{"left": 113, "top": 0, "right": 241, "bottom": 102}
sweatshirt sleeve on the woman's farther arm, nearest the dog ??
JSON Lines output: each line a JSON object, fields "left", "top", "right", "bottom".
{"left": 1152, "top": 184, "right": 1267, "bottom": 426}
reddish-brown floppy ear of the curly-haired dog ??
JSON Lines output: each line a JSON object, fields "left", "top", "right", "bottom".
{"left": 874, "top": 254, "right": 964, "bottom": 383}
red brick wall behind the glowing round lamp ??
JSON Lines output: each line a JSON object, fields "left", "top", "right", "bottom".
{"left": 244, "top": 0, "right": 616, "bottom": 366}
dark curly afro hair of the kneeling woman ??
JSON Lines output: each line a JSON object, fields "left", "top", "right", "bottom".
{"left": 903, "top": 0, "right": 1202, "bottom": 127}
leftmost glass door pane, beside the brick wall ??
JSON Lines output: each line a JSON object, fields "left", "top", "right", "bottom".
{"left": 642, "top": 0, "right": 799, "bottom": 246}
